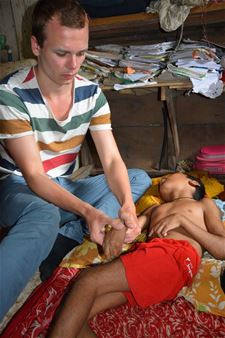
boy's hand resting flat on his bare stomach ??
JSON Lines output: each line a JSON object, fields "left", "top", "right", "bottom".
{"left": 149, "top": 213, "right": 182, "bottom": 237}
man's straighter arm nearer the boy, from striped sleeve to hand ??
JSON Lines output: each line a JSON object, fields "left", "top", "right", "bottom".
{"left": 91, "top": 130, "right": 141, "bottom": 242}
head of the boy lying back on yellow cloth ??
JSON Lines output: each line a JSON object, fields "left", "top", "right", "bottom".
{"left": 159, "top": 172, "right": 205, "bottom": 201}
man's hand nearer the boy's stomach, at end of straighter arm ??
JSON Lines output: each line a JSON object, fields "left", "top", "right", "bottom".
{"left": 119, "top": 207, "right": 141, "bottom": 243}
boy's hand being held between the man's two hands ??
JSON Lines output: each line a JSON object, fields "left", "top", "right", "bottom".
{"left": 102, "top": 226, "right": 126, "bottom": 259}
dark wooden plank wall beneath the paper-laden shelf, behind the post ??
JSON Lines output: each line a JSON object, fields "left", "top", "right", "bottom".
{"left": 100, "top": 90, "right": 225, "bottom": 171}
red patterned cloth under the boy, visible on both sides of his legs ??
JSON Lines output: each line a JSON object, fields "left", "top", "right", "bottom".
{"left": 1, "top": 268, "right": 225, "bottom": 338}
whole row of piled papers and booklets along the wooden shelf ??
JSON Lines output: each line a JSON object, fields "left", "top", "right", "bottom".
{"left": 80, "top": 40, "right": 223, "bottom": 98}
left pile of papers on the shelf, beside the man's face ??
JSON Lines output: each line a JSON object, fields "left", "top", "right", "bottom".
{"left": 80, "top": 41, "right": 175, "bottom": 85}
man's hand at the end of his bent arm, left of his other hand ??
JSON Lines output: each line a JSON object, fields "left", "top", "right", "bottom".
{"left": 85, "top": 207, "right": 124, "bottom": 245}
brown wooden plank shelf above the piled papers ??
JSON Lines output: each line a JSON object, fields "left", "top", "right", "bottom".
{"left": 90, "top": 3, "right": 225, "bottom": 47}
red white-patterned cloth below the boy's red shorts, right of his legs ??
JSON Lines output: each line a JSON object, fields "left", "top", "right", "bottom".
{"left": 90, "top": 297, "right": 225, "bottom": 338}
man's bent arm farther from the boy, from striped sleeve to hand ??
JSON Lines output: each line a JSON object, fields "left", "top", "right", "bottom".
{"left": 5, "top": 135, "right": 124, "bottom": 244}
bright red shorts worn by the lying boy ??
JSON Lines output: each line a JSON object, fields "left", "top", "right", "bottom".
{"left": 120, "top": 238, "right": 200, "bottom": 308}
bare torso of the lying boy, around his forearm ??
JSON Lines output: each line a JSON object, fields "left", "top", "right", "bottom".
{"left": 150, "top": 199, "right": 206, "bottom": 256}
